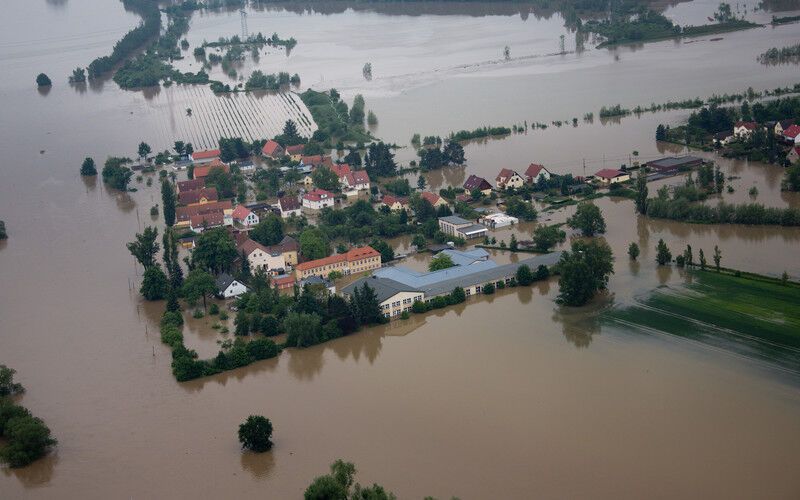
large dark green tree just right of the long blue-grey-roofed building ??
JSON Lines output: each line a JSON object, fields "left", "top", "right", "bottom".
{"left": 558, "top": 240, "right": 614, "bottom": 306}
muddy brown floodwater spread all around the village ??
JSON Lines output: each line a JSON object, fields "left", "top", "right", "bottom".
{"left": 0, "top": 0, "right": 800, "bottom": 499}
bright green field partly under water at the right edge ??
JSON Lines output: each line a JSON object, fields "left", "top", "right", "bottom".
{"left": 605, "top": 271, "right": 800, "bottom": 371}
